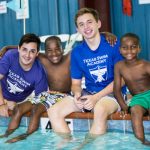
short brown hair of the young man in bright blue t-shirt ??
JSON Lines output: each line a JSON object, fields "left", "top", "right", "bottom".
{"left": 74, "top": 8, "right": 99, "bottom": 27}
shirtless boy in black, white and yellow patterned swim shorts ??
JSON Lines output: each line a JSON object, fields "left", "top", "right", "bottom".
{"left": 2, "top": 33, "right": 115, "bottom": 143}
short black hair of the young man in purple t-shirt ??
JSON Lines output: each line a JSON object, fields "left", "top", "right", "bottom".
{"left": 19, "top": 33, "right": 41, "bottom": 51}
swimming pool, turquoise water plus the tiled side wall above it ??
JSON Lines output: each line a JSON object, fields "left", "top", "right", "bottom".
{"left": 0, "top": 117, "right": 150, "bottom": 150}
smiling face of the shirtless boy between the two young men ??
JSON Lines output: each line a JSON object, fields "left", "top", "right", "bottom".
{"left": 45, "top": 39, "right": 63, "bottom": 64}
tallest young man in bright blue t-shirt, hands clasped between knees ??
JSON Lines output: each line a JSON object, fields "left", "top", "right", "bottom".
{"left": 48, "top": 8, "right": 123, "bottom": 136}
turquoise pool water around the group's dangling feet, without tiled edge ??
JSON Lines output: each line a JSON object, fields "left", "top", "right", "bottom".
{"left": 0, "top": 127, "right": 150, "bottom": 150}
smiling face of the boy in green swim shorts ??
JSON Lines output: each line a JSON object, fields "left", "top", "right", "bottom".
{"left": 120, "top": 36, "right": 140, "bottom": 60}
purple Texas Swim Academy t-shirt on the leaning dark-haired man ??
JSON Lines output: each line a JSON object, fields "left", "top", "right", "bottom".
{"left": 0, "top": 49, "right": 48, "bottom": 102}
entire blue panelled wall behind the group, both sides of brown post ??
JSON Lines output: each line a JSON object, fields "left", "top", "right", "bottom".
{"left": 0, "top": 0, "right": 150, "bottom": 60}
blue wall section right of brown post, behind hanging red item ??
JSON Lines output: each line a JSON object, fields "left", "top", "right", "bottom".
{"left": 110, "top": 0, "right": 150, "bottom": 60}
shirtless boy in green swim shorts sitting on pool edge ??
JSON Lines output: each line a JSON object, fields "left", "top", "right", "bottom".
{"left": 114, "top": 33, "right": 150, "bottom": 145}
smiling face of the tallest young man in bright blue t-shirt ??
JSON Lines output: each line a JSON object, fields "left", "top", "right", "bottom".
{"left": 77, "top": 13, "right": 101, "bottom": 39}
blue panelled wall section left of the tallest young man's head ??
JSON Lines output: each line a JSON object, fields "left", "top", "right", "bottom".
{"left": 0, "top": 0, "right": 78, "bottom": 49}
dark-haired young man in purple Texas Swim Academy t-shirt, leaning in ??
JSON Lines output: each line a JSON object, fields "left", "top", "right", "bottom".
{"left": 0, "top": 33, "right": 48, "bottom": 116}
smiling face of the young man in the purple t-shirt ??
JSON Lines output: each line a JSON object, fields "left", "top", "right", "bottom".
{"left": 18, "top": 42, "right": 38, "bottom": 71}
